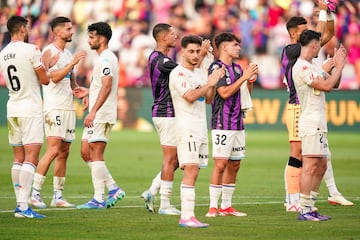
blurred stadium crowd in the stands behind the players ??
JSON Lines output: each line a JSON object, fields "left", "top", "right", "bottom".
{"left": 0, "top": 0, "right": 360, "bottom": 89}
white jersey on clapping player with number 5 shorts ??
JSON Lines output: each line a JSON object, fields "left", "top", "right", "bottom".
{"left": 43, "top": 44, "right": 75, "bottom": 111}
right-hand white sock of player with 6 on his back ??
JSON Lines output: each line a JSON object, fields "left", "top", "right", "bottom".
{"left": 18, "top": 162, "right": 35, "bottom": 210}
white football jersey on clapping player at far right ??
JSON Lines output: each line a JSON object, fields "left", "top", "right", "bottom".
{"left": 293, "top": 58, "right": 327, "bottom": 136}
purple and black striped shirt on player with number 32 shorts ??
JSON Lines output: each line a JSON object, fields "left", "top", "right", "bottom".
{"left": 209, "top": 60, "right": 244, "bottom": 130}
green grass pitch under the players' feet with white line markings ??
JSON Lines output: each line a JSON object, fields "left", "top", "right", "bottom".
{"left": 0, "top": 127, "right": 360, "bottom": 240}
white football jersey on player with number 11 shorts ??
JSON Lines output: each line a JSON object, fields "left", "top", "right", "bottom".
{"left": 169, "top": 65, "right": 208, "bottom": 142}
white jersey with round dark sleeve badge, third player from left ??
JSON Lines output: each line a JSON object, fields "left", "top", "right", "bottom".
{"left": 89, "top": 49, "right": 119, "bottom": 124}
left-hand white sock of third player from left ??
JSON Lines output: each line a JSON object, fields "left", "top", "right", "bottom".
{"left": 90, "top": 161, "right": 106, "bottom": 203}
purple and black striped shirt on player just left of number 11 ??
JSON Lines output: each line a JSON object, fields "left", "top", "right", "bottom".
{"left": 148, "top": 51, "right": 177, "bottom": 117}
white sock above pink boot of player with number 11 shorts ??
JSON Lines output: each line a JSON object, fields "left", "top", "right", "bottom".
{"left": 180, "top": 184, "right": 195, "bottom": 220}
